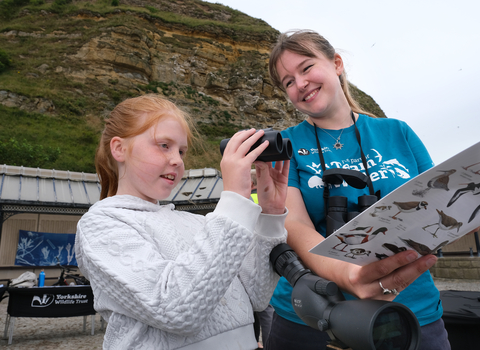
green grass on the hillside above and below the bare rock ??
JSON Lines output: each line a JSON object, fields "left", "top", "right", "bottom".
{"left": 0, "top": 0, "right": 275, "bottom": 172}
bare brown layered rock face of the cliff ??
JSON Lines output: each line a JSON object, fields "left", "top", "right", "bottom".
{"left": 68, "top": 11, "right": 302, "bottom": 128}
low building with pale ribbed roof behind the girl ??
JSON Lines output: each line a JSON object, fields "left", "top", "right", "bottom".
{"left": 0, "top": 165, "right": 223, "bottom": 284}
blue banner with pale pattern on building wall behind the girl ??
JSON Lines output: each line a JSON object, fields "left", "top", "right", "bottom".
{"left": 15, "top": 230, "right": 77, "bottom": 266}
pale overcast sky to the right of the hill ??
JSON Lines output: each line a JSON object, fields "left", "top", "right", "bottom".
{"left": 211, "top": 0, "right": 480, "bottom": 164}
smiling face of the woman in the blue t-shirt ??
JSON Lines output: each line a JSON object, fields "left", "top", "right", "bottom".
{"left": 276, "top": 51, "right": 345, "bottom": 118}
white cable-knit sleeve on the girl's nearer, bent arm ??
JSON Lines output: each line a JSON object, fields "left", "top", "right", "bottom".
{"left": 76, "top": 192, "right": 262, "bottom": 335}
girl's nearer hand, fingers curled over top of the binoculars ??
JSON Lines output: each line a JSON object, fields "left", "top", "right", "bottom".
{"left": 220, "top": 129, "right": 268, "bottom": 198}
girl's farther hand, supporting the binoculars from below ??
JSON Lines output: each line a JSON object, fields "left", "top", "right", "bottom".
{"left": 254, "top": 160, "right": 290, "bottom": 215}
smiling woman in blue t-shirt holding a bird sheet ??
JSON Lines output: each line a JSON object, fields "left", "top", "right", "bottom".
{"left": 266, "top": 31, "right": 450, "bottom": 350}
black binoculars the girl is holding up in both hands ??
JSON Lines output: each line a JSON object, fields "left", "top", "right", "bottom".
{"left": 220, "top": 128, "right": 293, "bottom": 162}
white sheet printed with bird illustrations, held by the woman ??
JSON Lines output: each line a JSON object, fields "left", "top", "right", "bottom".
{"left": 310, "top": 142, "right": 480, "bottom": 266}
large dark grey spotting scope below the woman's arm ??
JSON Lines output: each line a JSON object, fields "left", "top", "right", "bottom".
{"left": 270, "top": 243, "right": 421, "bottom": 350}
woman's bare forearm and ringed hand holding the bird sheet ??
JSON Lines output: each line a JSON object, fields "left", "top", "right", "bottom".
{"left": 285, "top": 187, "right": 437, "bottom": 301}
